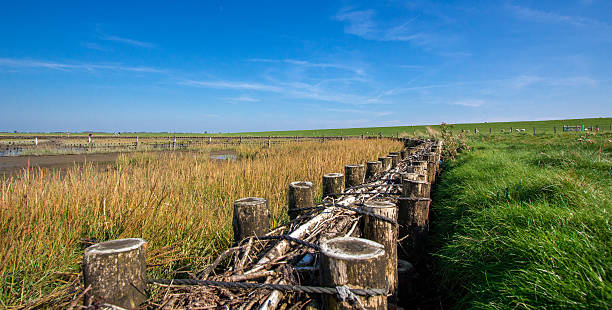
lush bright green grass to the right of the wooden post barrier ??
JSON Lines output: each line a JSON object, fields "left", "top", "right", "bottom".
{"left": 431, "top": 134, "right": 612, "bottom": 309}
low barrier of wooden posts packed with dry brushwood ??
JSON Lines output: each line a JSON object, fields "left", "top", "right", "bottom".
{"left": 84, "top": 140, "right": 442, "bottom": 309}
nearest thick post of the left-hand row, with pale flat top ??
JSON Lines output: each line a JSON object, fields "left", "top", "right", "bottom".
{"left": 83, "top": 238, "right": 147, "bottom": 309}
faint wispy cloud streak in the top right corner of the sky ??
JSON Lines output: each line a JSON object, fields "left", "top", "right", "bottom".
{"left": 508, "top": 5, "right": 611, "bottom": 29}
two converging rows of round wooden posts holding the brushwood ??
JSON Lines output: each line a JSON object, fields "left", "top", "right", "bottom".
{"left": 83, "top": 141, "right": 442, "bottom": 309}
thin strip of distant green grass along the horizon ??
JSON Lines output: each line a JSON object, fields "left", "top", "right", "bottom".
{"left": 0, "top": 117, "right": 612, "bottom": 137}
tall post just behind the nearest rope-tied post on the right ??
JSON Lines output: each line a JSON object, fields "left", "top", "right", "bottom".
{"left": 363, "top": 201, "right": 398, "bottom": 294}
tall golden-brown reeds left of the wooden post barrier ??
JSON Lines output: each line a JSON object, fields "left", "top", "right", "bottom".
{"left": 0, "top": 140, "right": 401, "bottom": 307}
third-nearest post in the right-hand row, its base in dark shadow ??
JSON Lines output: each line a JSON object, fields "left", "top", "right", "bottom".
{"left": 398, "top": 197, "right": 431, "bottom": 258}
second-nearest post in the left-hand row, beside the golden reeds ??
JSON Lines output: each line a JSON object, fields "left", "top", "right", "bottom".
{"left": 232, "top": 197, "right": 270, "bottom": 242}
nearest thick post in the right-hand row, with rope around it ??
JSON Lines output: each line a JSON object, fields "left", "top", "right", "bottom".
{"left": 320, "top": 237, "right": 387, "bottom": 310}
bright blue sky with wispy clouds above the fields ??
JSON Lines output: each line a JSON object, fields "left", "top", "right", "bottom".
{"left": 0, "top": 0, "right": 612, "bottom": 132}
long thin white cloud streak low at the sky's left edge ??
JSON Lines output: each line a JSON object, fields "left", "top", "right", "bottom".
{"left": 0, "top": 58, "right": 164, "bottom": 73}
